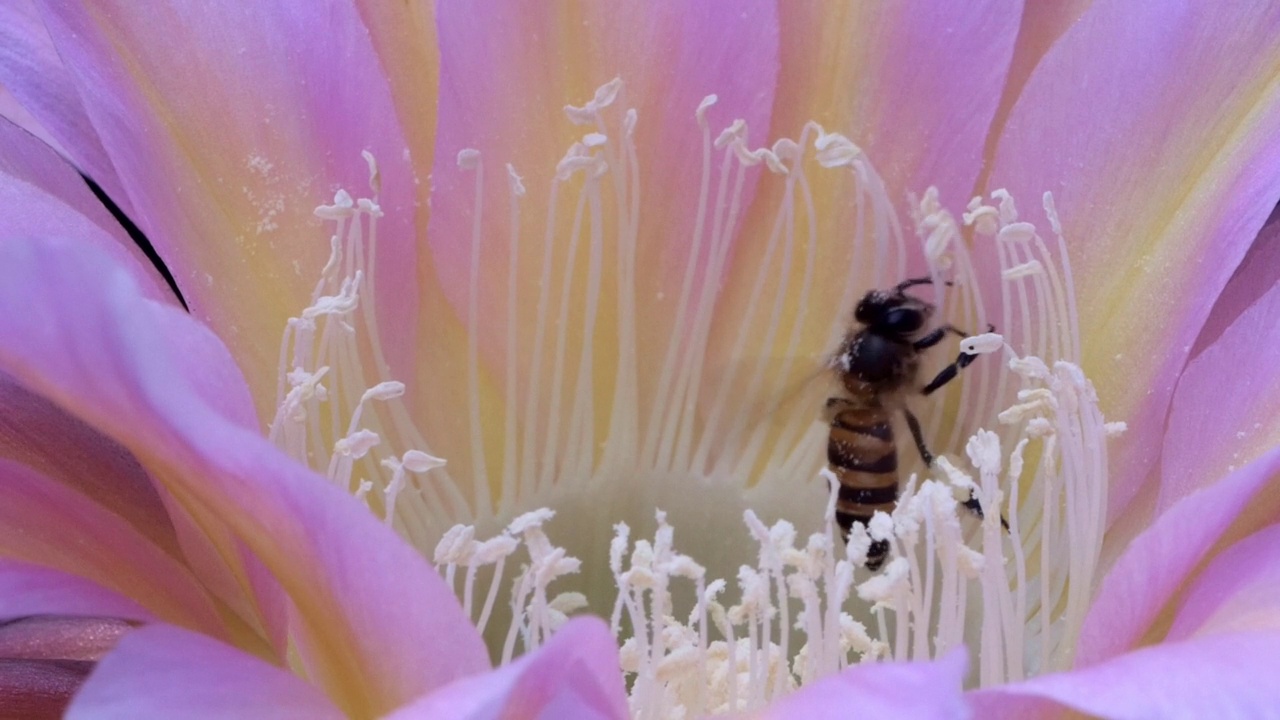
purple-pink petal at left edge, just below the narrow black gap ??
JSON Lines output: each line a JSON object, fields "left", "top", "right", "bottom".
{"left": 0, "top": 114, "right": 174, "bottom": 302}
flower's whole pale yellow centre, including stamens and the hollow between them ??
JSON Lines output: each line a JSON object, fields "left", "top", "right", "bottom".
{"left": 270, "top": 81, "right": 1123, "bottom": 717}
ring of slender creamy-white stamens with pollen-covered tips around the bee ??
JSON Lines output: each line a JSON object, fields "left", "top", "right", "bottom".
{"left": 270, "top": 75, "right": 1123, "bottom": 717}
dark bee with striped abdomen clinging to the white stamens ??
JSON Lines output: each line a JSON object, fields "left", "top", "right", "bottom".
{"left": 827, "top": 277, "right": 995, "bottom": 570}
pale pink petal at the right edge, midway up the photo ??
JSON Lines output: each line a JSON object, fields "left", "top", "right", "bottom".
{"left": 1157, "top": 231, "right": 1280, "bottom": 511}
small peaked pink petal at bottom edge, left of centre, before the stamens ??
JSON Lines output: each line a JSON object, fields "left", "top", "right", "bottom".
{"left": 388, "top": 618, "right": 630, "bottom": 720}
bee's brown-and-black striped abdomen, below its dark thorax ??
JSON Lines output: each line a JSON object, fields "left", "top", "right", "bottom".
{"left": 827, "top": 404, "right": 897, "bottom": 570}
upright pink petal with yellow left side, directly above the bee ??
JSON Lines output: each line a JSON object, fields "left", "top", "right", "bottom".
{"left": 776, "top": 0, "right": 1021, "bottom": 207}
